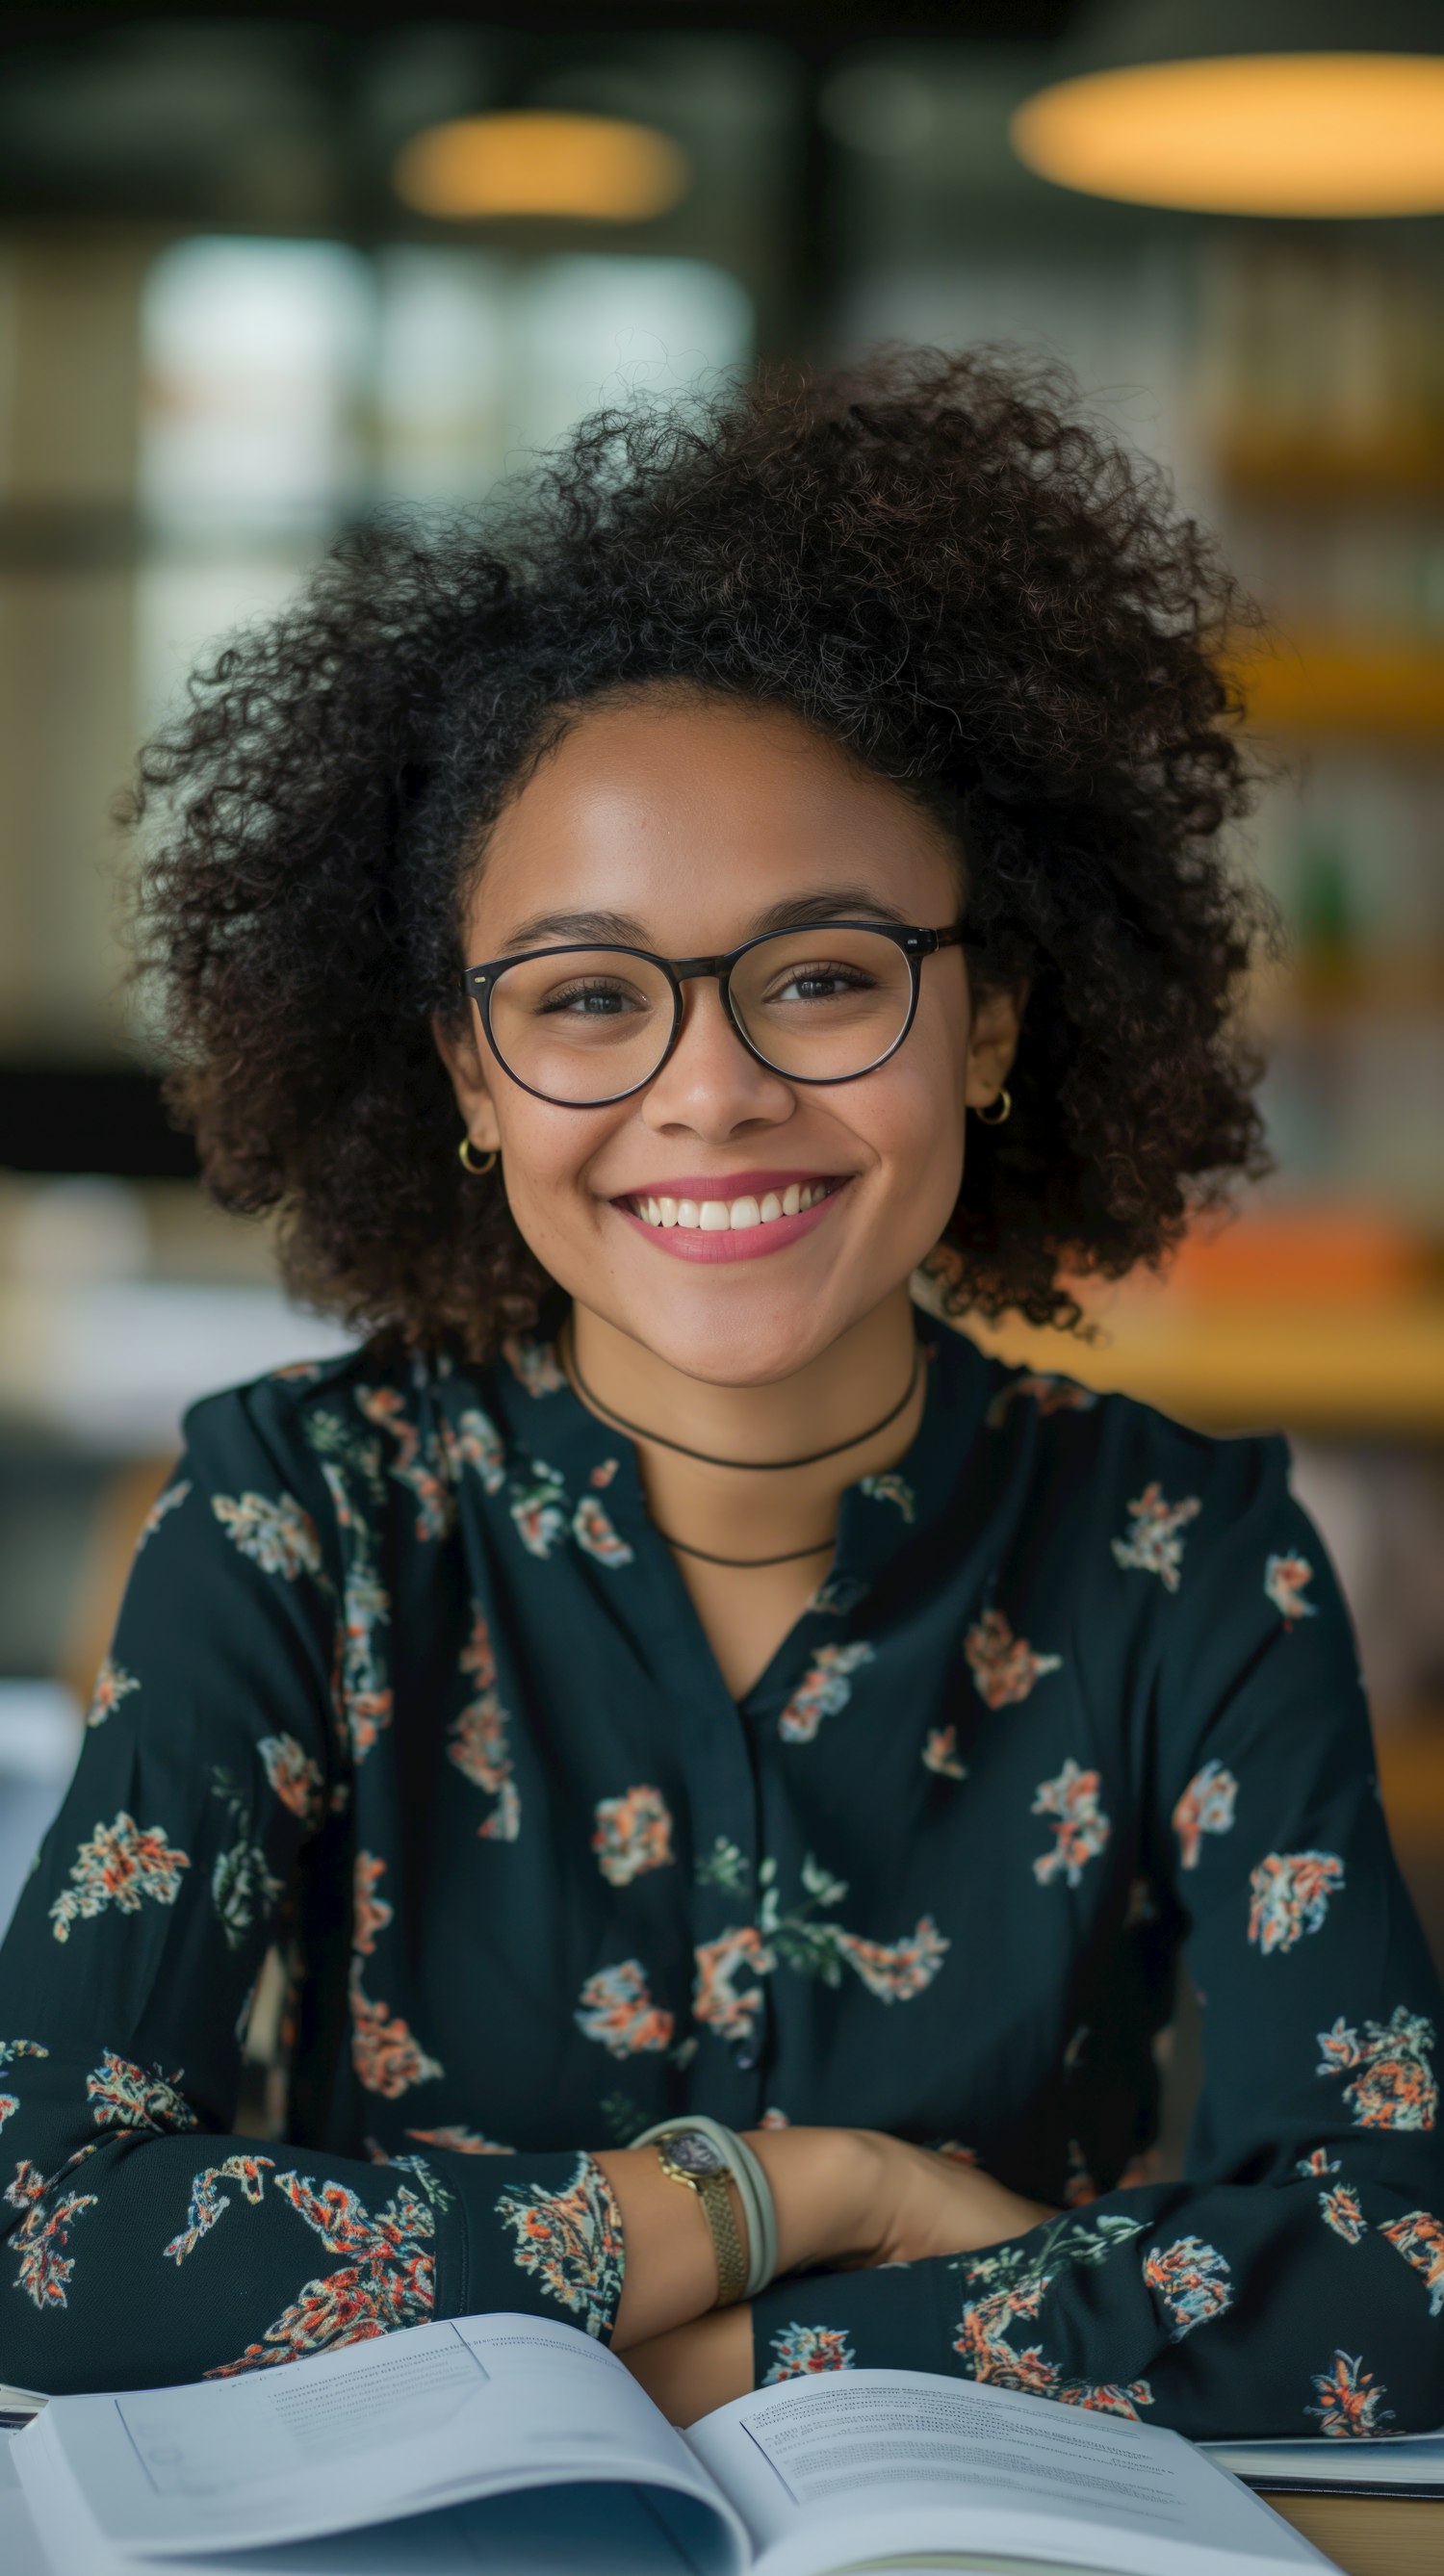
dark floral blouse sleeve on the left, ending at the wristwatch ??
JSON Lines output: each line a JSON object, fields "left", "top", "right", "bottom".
{"left": 0, "top": 1380, "right": 623, "bottom": 2393}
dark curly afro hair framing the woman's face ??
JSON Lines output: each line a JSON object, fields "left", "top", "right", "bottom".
{"left": 121, "top": 343, "right": 1279, "bottom": 1360}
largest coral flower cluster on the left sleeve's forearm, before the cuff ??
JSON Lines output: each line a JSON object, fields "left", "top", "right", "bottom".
{"left": 206, "top": 2156, "right": 437, "bottom": 2381}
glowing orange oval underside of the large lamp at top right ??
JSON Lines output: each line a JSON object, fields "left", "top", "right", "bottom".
{"left": 1009, "top": 54, "right": 1444, "bottom": 214}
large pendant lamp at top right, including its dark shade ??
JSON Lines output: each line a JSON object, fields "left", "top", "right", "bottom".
{"left": 1009, "top": 0, "right": 1444, "bottom": 217}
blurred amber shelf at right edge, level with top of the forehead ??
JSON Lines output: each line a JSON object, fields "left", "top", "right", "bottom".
{"left": 1230, "top": 633, "right": 1444, "bottom": 747}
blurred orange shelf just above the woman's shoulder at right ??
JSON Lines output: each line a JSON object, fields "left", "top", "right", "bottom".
{"left": 967, "top": 1288, "right": 1444, "bottom": 1440}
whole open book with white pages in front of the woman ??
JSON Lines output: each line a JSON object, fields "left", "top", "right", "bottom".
{"left": 11, "top": 2316, "right": 1330, "bottom": 2576}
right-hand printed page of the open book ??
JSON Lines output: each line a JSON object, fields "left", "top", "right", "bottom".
{"left": 687, "top": 2370, "right": 1328, "bottom": 2576}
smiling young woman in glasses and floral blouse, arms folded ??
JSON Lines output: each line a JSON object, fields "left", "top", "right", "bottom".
{"left": 0, "top": 350, "right": 1444, "bottom": 2436}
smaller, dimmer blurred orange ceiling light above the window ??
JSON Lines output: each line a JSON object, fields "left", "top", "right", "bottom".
{"left": 391, "top": 111, "right": 692, "bottom": 224}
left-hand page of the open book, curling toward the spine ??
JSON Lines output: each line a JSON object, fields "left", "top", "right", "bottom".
{"left": 13, "top": 2316, "right": 746, "bottom": 2568}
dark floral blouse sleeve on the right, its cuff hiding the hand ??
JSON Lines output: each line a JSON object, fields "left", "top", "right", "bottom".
{"left": 754, "top": 1435, "right": 1444, "bottom": 2439}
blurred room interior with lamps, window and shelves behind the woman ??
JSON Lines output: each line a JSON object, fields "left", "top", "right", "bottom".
{"left": 0, "top": 0, "right": 1444, "bottom": 2132}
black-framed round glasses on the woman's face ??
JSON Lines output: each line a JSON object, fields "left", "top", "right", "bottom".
{"left": 461, "top": 922, "right": 983, "bottom": 1108}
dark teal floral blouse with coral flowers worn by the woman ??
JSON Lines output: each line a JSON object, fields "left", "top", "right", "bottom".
{"left": 0, "top": 1306, "right": 1444, "bottom": 2439}
